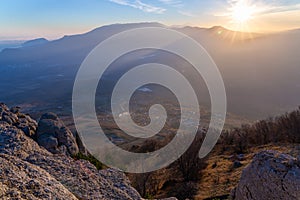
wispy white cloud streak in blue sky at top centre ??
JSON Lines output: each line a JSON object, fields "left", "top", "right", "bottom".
{"left": 109, "top": 0, "right": 168, "bottom": 14}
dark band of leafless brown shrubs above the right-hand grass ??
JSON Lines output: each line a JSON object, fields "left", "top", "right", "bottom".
{"left": 219, "top": 107, "right": 300, "bottom": 153}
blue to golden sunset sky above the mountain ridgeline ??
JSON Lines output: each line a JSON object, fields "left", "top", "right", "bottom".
{"left": 0, "top": 0, "right": 300, "bottom": 40}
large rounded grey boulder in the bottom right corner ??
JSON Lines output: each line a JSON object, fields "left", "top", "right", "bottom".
{"left": 232, "top": 151, "right": 300, "bottom": 200}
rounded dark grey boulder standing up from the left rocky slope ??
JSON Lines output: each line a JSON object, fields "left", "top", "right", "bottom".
{"left": 36, "top": 113, "right": 79, "bottom": 155}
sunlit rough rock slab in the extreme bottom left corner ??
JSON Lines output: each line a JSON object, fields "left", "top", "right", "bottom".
{"left": 0, "top": 153, "right": 77, "bottom": 200}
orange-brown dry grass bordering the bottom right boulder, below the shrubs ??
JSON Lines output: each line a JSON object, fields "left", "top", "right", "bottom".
{"left": 195, "top": 144, "right": 300, "bottom": 200}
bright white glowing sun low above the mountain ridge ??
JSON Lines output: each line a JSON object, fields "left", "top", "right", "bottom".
{"left": 230, "top": 0, "right": 255, "bottom": 24}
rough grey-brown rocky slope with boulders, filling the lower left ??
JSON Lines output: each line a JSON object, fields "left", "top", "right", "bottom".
{"left": 0, "top": 104, "right": 142, "bottom": 199}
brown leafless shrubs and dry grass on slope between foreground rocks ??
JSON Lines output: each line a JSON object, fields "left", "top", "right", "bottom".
{"left": 129, "top": 107, "right": 300, "bottom": 199}
